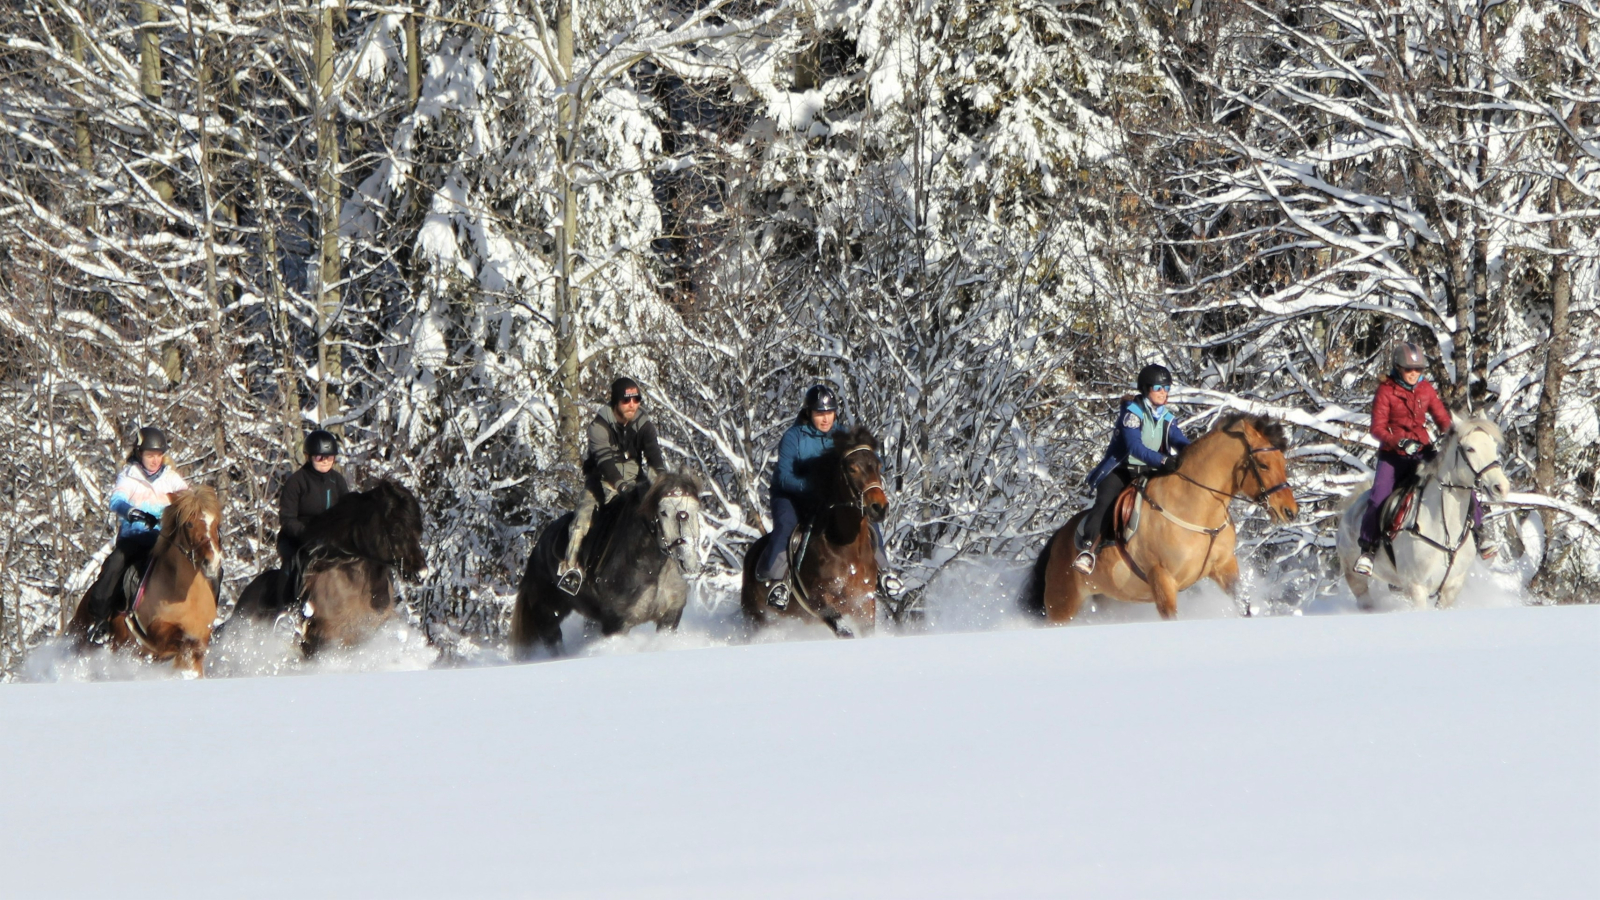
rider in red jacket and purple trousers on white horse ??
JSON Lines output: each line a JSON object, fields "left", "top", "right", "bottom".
{"left": 1354, "top": 341, "right": 1499, "bottom": 575}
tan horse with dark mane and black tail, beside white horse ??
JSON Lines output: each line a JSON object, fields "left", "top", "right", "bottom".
{"left": 1022, "top": 413, "right": 1299, "bottom": 625}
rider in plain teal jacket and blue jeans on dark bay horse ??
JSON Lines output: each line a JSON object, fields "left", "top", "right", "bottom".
{"left": 755, "top": 384, "right": 899, "bottom": 610}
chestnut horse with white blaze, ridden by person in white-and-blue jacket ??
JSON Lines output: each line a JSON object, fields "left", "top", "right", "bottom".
{"left": 67, "top": 485, "right": 222, "bottom": 677}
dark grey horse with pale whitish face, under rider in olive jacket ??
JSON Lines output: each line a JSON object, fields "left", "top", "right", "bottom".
{"left": 510, "top": 472, "right": 701, "bottom": 650}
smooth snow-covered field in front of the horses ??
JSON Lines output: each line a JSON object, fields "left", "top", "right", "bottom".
{"left": 0, "top": 565, "right": 1600, "bottom": 898}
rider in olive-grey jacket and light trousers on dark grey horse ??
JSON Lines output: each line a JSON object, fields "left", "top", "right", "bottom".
{"left": 557, "top": 375, "right": 667, "bottom": 594}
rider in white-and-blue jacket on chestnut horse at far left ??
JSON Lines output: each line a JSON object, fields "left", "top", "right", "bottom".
{"left": 88, "top": 428, "right": 189, "bottom": 644}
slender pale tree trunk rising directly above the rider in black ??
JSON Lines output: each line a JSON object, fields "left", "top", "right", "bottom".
{"left": 314, "top": 3, "right": 344, "bottom": 431}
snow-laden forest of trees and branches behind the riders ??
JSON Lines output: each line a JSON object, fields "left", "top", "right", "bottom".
{"left": 0, "top": 0, "right": 1600, "bottom": 673}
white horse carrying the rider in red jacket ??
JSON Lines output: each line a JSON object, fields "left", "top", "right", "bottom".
{"left": 1338, "top": 413, "right": 1510, "bottom": 610}
